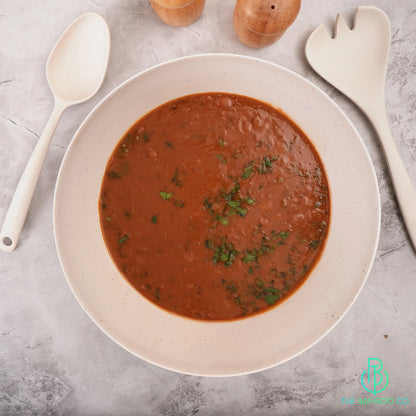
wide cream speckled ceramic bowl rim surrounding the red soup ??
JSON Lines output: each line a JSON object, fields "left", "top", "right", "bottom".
{"left": 54, "top": 54, "right": 380, "bottom": 376}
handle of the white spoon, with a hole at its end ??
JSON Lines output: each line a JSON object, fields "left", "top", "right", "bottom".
{"left": 0, "top": 101, "right": 66, "bottom": 253}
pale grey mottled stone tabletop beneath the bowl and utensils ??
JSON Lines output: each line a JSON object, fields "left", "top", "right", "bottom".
{"left": 0, "top": 0, "right": 416, "bottom": 416}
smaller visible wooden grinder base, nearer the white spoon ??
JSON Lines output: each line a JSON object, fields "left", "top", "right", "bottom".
{"left": 150, "top": 0, "right": 205, "bottom": 26}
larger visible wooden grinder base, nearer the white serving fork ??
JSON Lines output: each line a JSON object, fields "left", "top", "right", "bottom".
{"left": 233, "top": 0, "right": 301, "bottom": 48}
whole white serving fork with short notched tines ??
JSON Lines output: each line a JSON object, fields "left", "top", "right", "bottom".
{"left": 305, "top": 6, "right": 416, "bottom": 250}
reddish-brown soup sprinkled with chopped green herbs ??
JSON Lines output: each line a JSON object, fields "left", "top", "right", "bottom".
{"left": 99, "top": 93, "right": 330, "bottom": 320}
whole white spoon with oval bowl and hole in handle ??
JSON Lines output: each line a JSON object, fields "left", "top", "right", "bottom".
{"left": 0, "top": 13, "right": 110, "bottom": 252}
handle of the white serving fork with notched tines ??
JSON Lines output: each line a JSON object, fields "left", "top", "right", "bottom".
{"left": 366, "top": 104, "right": 416, "bottom": 250}
